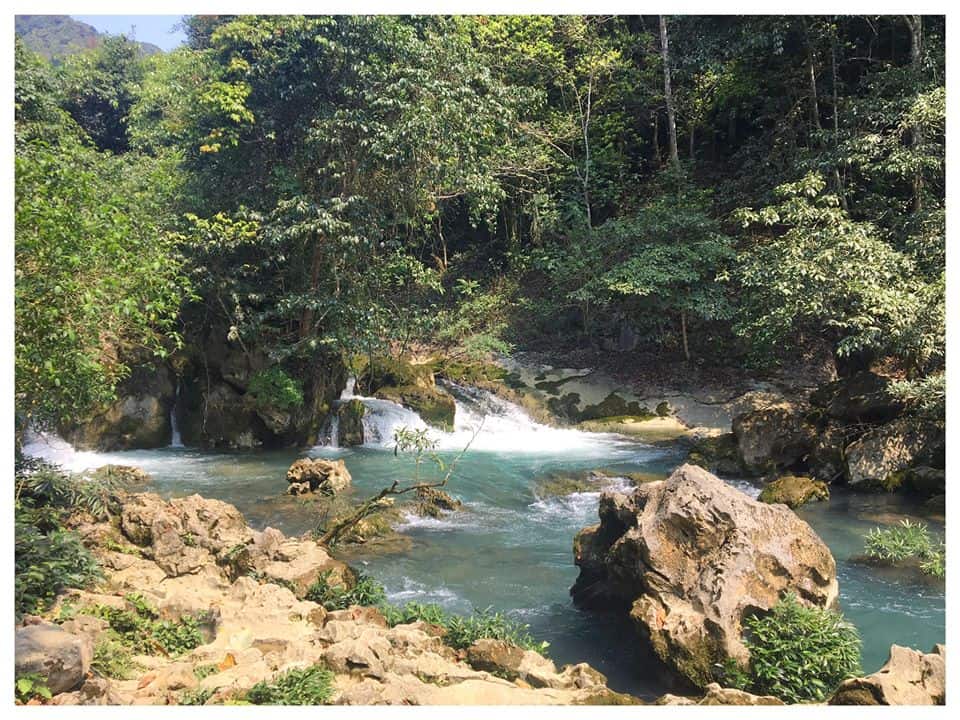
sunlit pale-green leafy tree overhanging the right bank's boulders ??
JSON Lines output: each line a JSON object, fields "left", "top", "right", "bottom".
{"left": 737, "top": 174, "right": 944, "bottom": 366}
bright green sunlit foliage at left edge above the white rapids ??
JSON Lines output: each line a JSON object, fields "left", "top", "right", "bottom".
{"left": 15, "top": 111, "right": 187, "bottom": 426}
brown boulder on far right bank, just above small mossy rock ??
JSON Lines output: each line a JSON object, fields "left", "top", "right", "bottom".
{"left": 733, "top": 401, "right": 818, "bottom": 475}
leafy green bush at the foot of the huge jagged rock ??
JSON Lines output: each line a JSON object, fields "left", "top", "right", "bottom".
{"left": 723, "top": 593, "right": 861, "bottom": 703}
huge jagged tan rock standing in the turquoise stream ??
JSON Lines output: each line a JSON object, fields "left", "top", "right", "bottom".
{"left": 570, "top": 465, "right": 837, "bottom": 687}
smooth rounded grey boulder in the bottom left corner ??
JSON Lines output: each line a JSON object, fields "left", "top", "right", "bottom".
{"left": 14, "top": 622, "right": 93, "bottom": 695}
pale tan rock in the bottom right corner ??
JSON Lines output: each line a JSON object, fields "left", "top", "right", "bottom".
{"left": 828, "top": 645, "right": 947, "bottom": 705}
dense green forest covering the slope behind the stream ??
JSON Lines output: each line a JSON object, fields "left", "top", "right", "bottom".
{"left": 16, "top": 16, "right": 945, "bottom": 434}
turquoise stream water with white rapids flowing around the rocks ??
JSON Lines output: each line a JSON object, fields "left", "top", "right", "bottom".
{"left": 22, "top": 390, "right": 945, "bottom": 697}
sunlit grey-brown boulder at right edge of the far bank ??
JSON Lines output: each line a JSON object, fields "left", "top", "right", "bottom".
{"left": 844, "top": 417, "right": 943, "bottom": 490}
